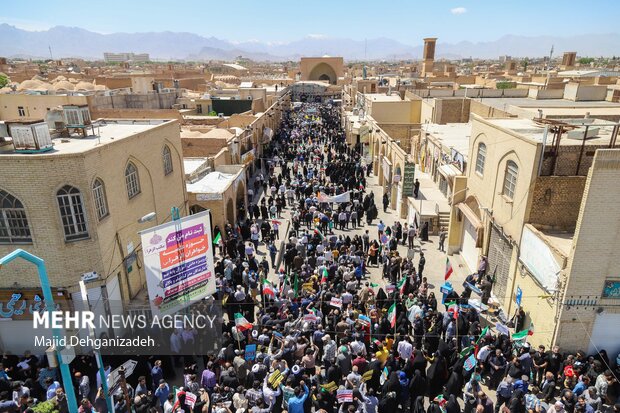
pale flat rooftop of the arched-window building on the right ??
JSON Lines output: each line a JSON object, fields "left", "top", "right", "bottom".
{"left": 484, "top": 118, "right": 613, "bottom": 146}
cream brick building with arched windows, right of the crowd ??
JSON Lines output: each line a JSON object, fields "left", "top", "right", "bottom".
{"left": 448, "top": 115, "right": 620, "bottom": 354}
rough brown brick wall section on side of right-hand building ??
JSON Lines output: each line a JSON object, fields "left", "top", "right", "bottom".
{"left": 529, "top": 176, "right": 586, "bottom": 230}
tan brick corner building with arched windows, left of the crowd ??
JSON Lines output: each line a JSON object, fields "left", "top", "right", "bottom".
{"left": 0, "top": 116, "right": 188, "bottom": 348}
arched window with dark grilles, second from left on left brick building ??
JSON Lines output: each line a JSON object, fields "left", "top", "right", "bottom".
{"left": 56, "top": 185, "right": 88, "bottom": 241}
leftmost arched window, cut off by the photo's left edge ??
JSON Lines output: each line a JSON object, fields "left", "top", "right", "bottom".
{"left": 0, "top": 189, "right": 32, "bottom": 244}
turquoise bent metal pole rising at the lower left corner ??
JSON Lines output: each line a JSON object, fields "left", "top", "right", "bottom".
{"left": 0, "top": 248, "right": 78, "bottom": 413}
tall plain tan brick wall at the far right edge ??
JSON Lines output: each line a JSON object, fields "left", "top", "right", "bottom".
{"left": 556, "top": 149, "right": 620, "bottom": 356}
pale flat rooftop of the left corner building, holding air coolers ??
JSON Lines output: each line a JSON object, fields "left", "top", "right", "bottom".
{"left": 0, "top": 119, "right": 174, "bottom": 157}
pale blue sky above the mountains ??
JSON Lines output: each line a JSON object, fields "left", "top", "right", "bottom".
{"left": 0, "top": 0, "right": 620, "bottom": 45}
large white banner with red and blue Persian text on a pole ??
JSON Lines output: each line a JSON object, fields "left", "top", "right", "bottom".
{"left": 140, "top": 211, "right": 215, "bottom": 315}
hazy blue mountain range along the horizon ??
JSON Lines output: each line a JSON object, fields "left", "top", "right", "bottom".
{"left": 0, "top": 23, "right": 620, "bottom": 61}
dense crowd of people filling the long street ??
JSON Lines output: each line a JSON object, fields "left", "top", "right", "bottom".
{"left": 0, "top": 104, "right": 620, "bottom": 413}
